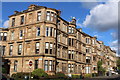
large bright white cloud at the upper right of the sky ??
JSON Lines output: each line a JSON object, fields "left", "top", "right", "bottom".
{"left": 83, "top": 1, "right": 118, "bottom": 31}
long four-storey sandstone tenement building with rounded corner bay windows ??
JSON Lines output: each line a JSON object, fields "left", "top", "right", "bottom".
{"left": 0, "top": 4, "right": 116, "bottom": 75}
